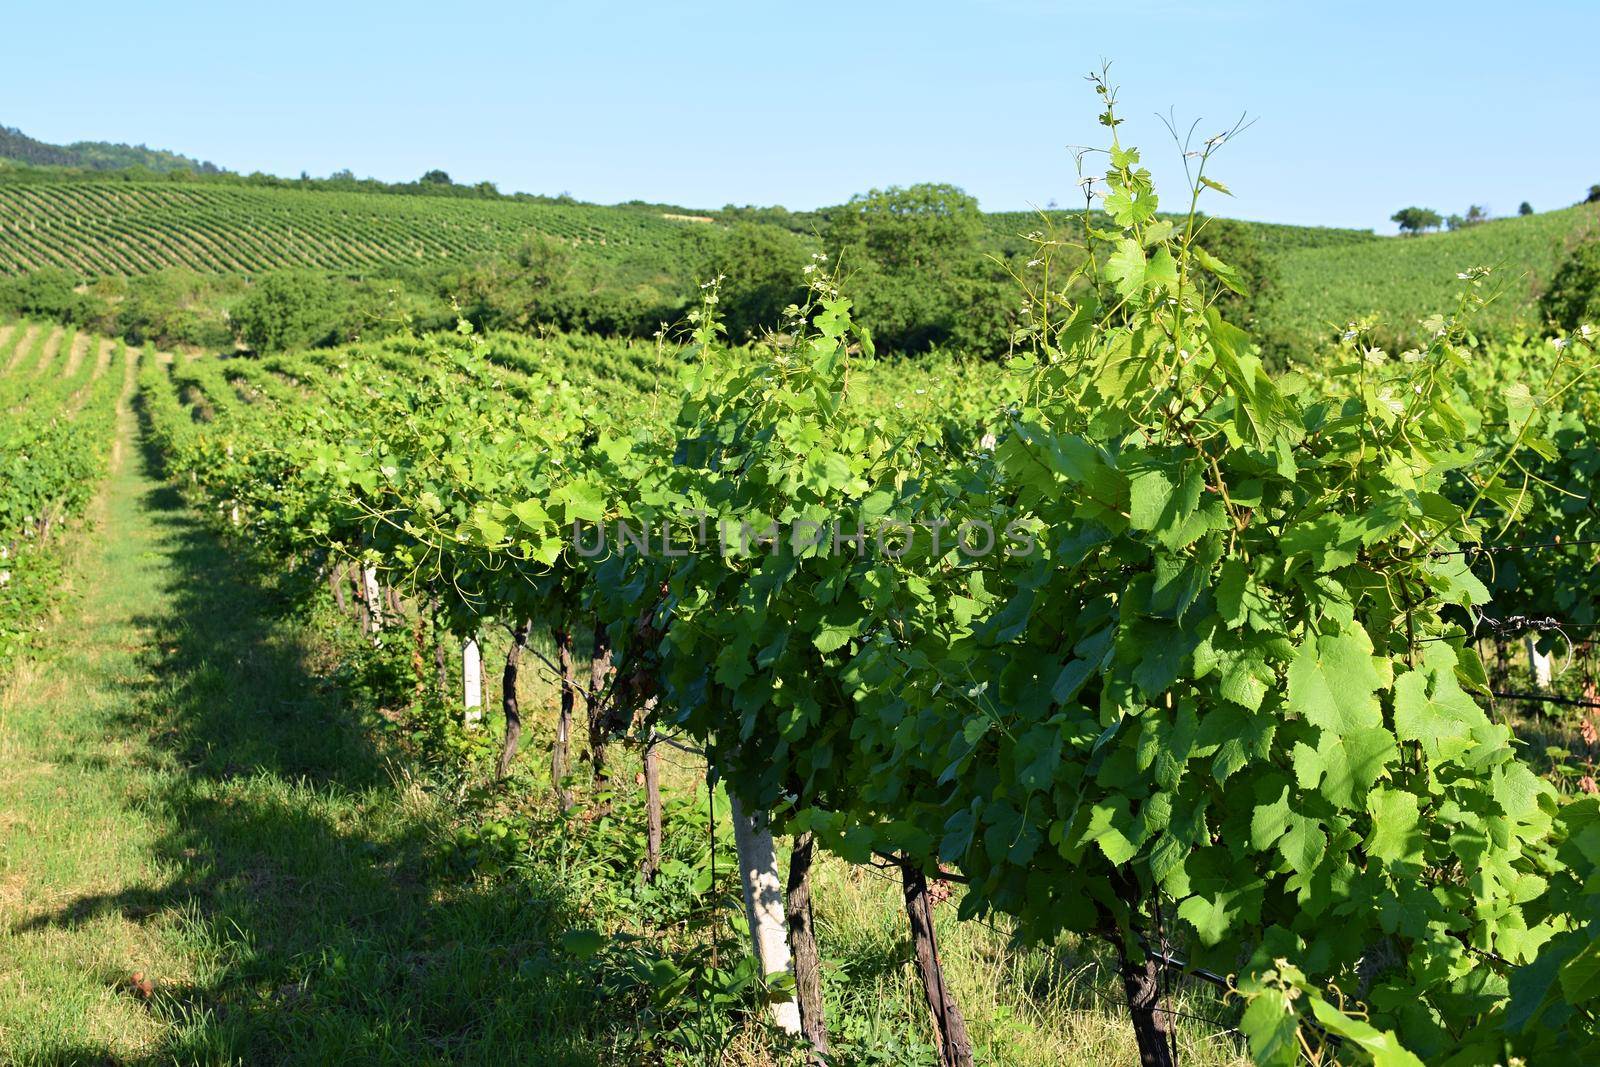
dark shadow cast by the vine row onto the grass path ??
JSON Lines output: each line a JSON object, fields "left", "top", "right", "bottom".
{"left": 9, "top": 422, "right": 632, "bottom": 1064}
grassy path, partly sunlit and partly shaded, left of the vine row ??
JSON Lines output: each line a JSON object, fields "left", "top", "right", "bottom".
{"left": 0, "top": 364, "right": 589, "bottom": 1064}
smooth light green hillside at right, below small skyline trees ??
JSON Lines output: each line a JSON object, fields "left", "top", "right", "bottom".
{"left": 1262, "top": 206, "right": 1600, "bottom": 346}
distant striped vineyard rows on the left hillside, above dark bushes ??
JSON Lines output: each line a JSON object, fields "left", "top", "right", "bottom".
{"left": 0, "top": 181, "right": 707, "bottom": 277}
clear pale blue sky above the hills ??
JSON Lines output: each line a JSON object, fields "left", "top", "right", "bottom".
{"left": 0, "top": 0, "right": 1600, "bottom": 232}
